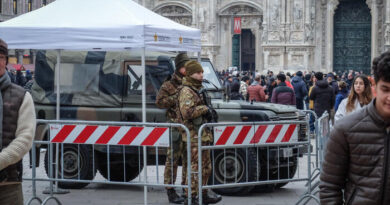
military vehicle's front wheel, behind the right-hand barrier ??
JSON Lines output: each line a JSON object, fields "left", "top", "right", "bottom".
{"left": 209, "top": 149, "right": 257, "bottom": 196}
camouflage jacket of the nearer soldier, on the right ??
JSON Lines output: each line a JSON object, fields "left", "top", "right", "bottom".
{"left": 177, "top": 77, "right": 213, "bottom": 143}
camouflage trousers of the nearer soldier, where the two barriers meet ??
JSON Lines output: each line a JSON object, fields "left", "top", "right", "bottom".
{"left": 183, "top": 142, "right": 211, "bottom": 197}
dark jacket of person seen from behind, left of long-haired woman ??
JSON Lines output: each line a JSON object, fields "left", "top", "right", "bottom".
{"left": 310, "top": 80, "right": 335, "bottom": 117}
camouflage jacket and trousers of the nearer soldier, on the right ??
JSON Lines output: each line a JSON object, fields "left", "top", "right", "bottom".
{"left": 178, "top": 77, "right": 213, "bottom": 197}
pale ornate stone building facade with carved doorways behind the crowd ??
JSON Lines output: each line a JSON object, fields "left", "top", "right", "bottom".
{"left": 0, "top": 0, "right": 390, "bottom": 73}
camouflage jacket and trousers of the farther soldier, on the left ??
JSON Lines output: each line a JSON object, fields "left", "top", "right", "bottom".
{"left": 156, "top": 73, "right": 185, "bottom": 187}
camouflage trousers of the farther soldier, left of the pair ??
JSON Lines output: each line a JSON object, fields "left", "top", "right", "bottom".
{"left": 164, "top": 136, "right": 185, "bottom": 189}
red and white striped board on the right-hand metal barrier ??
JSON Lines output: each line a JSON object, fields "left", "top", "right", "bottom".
{"left": 214, "top": 124, "right": 298, "bottom": 146}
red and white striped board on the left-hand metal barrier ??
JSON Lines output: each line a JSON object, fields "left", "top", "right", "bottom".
{"left": 50, "top": 124, "right": 169, "bottom": 147}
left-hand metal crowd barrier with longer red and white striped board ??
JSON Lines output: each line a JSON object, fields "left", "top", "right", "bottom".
{"left": 24, "top": 120, "right": 191, "bottom": 204}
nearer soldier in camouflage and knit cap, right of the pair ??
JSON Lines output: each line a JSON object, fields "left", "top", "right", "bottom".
{"left": 177, "top": 61, "right": 222, "bottom": 204}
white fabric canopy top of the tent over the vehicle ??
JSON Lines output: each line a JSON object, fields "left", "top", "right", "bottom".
{"left": 0, "top": 0, "right": 200, "bottom": 52}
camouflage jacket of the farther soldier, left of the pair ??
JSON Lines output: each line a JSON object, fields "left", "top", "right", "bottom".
{"left": 156, "top": 73, "right": 182, "bottom": 122}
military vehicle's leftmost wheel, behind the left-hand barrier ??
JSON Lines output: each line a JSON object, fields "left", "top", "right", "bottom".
{"left": 45, "top": 144, "right": 96, "bottom": 189}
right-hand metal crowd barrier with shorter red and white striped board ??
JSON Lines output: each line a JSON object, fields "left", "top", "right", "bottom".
{"left": 198, "top": 118, "right": 319, "bottom": 204}
